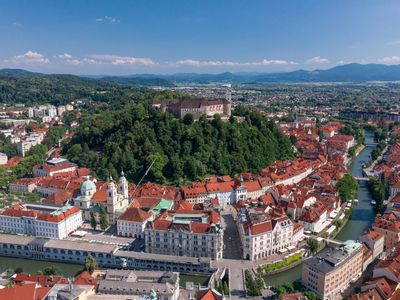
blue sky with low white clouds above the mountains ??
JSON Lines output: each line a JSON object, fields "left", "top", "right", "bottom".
{"left": 0, "top": 0, "right": 400, "bottom": 74}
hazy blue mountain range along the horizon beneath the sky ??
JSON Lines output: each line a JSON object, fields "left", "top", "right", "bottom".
{"left": 0, "top": 63, "right": 400, "bottom": 86}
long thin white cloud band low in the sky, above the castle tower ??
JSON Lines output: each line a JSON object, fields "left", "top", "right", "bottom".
{"left": 172, "top": 59, "right": 297, "bottom": 67}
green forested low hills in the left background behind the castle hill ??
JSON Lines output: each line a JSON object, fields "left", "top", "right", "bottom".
{"left": 0, "top": 72, "right": 176, "bottom": 105}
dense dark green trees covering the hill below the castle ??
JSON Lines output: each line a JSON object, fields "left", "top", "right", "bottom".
{"left": 65, "top": 104, "right": 293, "bottom": 184}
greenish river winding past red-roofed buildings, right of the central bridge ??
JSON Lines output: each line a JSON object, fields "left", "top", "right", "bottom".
{"left": 264, "top": 133, "right": 375, "bottom": 286}
